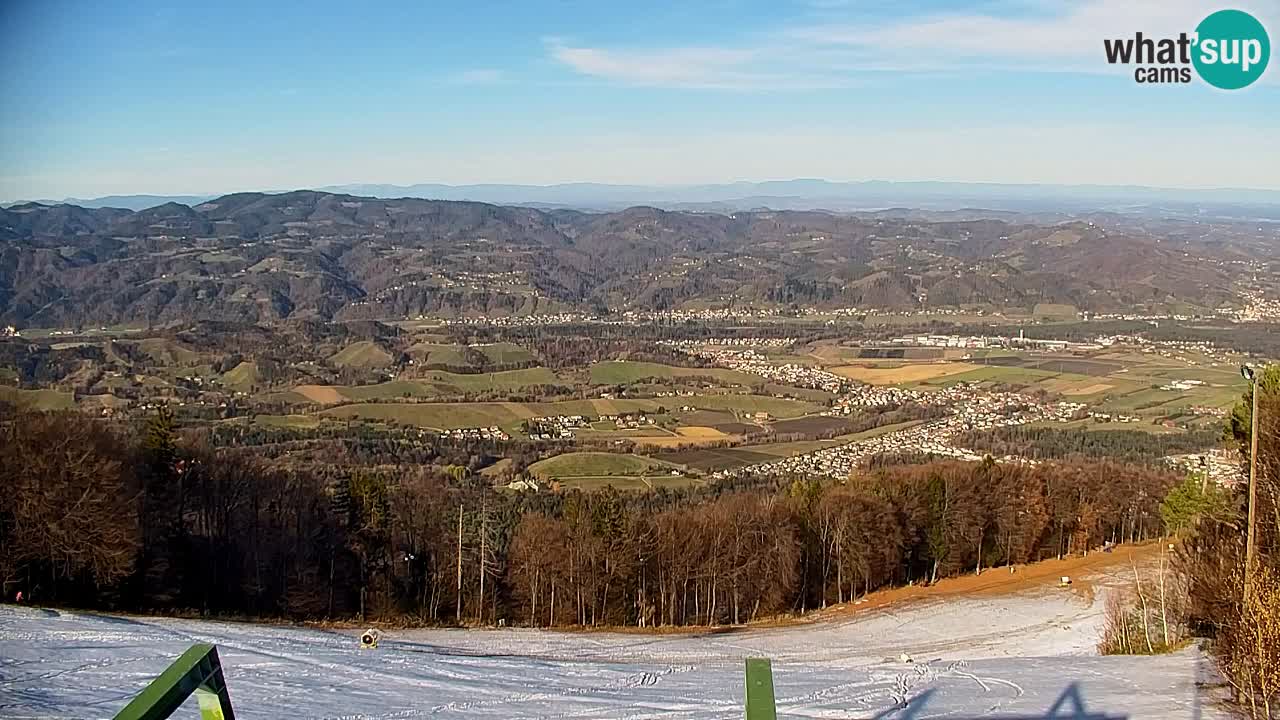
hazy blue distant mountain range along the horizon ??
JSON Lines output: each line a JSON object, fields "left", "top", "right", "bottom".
{"left": 10, "top": 179, "right": 1280, "bottom": 220}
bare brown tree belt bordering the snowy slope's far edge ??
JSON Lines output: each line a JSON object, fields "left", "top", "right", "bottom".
{"left": 0, "top": 413, "right": 1179, "bottom": 626}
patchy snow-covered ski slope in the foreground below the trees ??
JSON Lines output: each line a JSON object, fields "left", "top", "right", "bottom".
{"left": 0, "top": 576, "right": 1226, "bottom": 720}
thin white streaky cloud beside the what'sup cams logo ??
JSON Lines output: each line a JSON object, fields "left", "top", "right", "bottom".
{"left": 549, "top": 0, "right": 1280, "bottom": 90}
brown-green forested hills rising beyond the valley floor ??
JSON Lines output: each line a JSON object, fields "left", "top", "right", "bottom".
{"left": 0, "top": 191, "right": 1240, "bottom": 328}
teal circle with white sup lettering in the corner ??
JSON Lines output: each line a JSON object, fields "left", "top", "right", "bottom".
{"left": 1192, "top": 10, "right": 1271, "bottom": 90}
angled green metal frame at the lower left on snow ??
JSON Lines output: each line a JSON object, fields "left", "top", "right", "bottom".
{"left": 115, "top": 643, "right": 236, "bottom": 720}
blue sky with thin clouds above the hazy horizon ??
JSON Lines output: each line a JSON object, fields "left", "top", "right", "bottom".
{"left": 0, "top": 0, "right": 1280, "bottom": 200}
